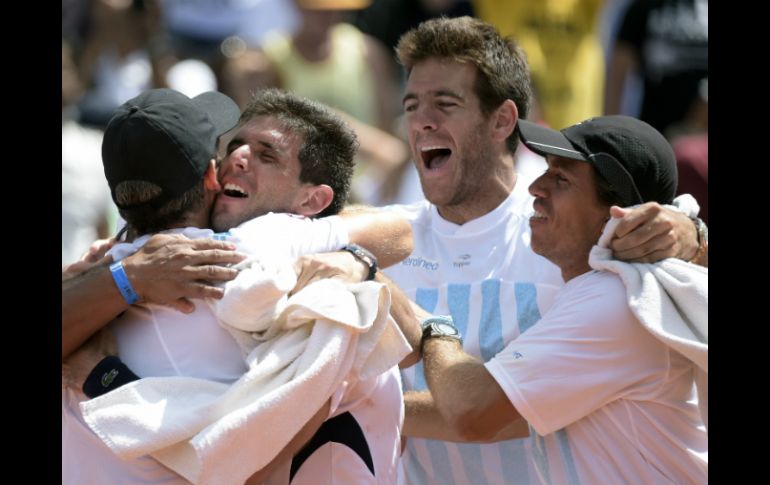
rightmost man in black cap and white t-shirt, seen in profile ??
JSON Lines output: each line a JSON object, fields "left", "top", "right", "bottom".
{"left": 422, "top": 116, "right": 708, "bottom": 483}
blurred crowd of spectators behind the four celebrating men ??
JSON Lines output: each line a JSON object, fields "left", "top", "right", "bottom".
{"left": 62, "top": 0, "right": 708, "bottom": 265}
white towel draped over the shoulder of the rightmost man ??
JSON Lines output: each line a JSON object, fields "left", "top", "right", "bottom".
{"left": 589, "top": 196, "right": 708, "bottom": 429}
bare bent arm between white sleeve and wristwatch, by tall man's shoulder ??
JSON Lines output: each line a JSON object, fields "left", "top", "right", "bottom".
{"left": 340, "top": 206, "right": 413, "bottom": 268}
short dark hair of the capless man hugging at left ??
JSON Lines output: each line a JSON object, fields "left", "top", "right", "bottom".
{"left": 240, "top": 89, "right": 358, "bottom": 217}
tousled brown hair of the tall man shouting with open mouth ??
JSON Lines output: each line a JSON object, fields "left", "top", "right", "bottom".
{"left": 396, "top": 17, "right": 532, "bottom": 153}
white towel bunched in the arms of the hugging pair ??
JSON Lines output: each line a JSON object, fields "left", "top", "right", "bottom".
{"left": 81, "top": 260, "right": 411, "bottom": 484}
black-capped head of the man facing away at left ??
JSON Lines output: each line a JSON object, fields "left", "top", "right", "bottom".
{"left": 102, "top": 89, "right": 240, "bottom": 236}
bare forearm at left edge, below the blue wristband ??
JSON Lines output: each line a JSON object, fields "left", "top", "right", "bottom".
{"left": 61, "top": 264, "right": 128, "bottom": 359}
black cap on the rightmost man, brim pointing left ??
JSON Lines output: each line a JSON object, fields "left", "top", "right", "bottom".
{"left": 518, "top": 115, "right": 677, "bottom": 207}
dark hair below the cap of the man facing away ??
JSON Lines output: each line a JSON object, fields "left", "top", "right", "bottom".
{"left": 114, "top": 178, "right": 205, "bottom": 236}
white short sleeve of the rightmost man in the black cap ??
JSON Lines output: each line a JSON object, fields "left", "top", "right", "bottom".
{"left": 485, "top": 273, "right": 667, "bottom": 436}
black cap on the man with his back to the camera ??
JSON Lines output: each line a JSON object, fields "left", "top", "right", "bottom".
{"left": 102, "top": 88, "right": 240, "bottom": 209}
